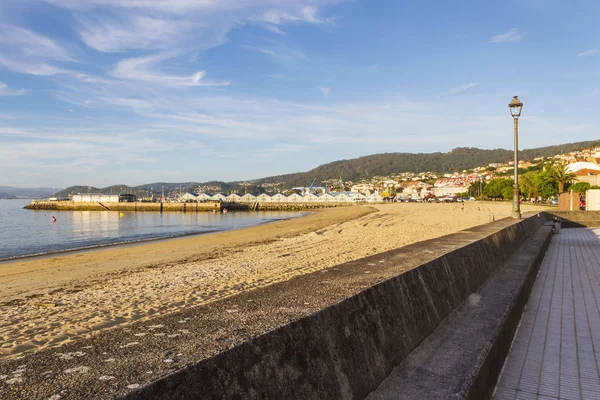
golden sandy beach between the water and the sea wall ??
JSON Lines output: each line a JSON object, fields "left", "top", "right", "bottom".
{"left": 0, "top": 202, "right": 542, "bottom": 358}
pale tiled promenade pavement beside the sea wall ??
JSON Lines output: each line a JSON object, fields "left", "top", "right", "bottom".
{"left": 494, "top": 228, "right": 600, "bottom": 400}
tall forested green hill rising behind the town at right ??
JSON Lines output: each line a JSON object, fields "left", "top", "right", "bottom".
{"left": 256, "top": 140, "right": 600, "bottom": 187}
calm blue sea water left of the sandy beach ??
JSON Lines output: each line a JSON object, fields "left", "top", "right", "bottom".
{"left": 0, "top": 199, "right": 302, "bottom": 260}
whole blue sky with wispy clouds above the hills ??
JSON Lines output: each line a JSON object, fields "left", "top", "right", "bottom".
{"left": 0, "top": 0, "right": 600, "bottom": 187}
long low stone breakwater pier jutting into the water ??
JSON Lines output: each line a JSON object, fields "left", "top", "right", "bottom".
{"left": 25, "top": 200, "right": 354, "bottom": 212}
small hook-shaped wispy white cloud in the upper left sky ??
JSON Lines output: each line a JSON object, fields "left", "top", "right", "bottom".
{"left": 111, "top": 53, "right": 229, "bottom": 86}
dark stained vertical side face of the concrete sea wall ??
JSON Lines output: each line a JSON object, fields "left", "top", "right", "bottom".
{"left": 125, "top": 214, "right": 547, "bottom": 399}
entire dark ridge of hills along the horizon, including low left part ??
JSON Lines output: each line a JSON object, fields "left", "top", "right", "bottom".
{"left": 55, "top": 140, "right": 600, "bottom": 197}
